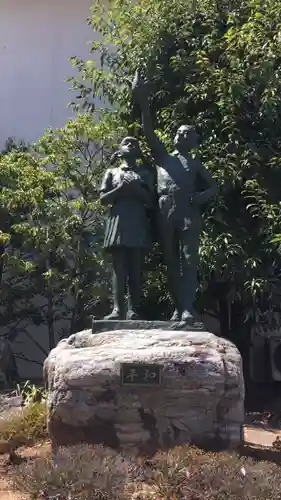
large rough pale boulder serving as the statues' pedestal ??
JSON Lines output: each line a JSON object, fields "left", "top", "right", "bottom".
{"left": 44, "top": 323, "right": 244, "bottom": 453}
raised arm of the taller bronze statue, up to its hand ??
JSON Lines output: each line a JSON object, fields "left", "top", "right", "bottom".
{"left": 132, "top": 71, "right": 166, "bottom": 160}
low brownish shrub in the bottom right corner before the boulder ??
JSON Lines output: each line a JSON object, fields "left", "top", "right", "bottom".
{"left": 145, "top": 447, "right": 281, "bottom": 500}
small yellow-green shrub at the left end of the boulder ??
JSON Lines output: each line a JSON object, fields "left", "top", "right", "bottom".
{"left": 0, "top": 401, "right": 48, "bottom": 444}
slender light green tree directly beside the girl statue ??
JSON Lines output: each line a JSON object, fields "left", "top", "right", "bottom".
{"left": 8, "top": 115, "right": 118, "bottom": 349}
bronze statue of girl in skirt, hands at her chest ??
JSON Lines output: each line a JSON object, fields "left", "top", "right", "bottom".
{"left": 100, "top": 137, "right": 154, "bottom": 320}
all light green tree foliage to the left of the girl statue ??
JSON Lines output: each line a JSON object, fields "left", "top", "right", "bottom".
{"left": 0, "top": 115, "right": 117, "bottom": 356}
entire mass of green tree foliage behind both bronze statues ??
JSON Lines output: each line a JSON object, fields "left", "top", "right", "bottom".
{"left": 0, "top": 0, "right": 281, "bottom": 355}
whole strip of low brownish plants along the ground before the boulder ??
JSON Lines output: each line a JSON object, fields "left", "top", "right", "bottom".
{"left": 8, "top": 445, "right": 281, "bottom": 500}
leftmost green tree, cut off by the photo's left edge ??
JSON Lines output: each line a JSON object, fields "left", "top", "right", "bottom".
{"left": 0, "top": 147, "right": 59, "bottom": 376}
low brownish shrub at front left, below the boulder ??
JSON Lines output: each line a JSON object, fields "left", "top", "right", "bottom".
{"left": 13, "top": 445, "right": 134, "bottom": 500}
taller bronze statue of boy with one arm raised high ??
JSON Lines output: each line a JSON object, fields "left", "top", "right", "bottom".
{"left": 133, "top": 71, "right": 216, "bottom": 324}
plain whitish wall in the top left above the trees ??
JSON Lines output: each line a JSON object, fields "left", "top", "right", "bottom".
{"left": 0, "top": 0, "right": 94, "bottom": 150}
